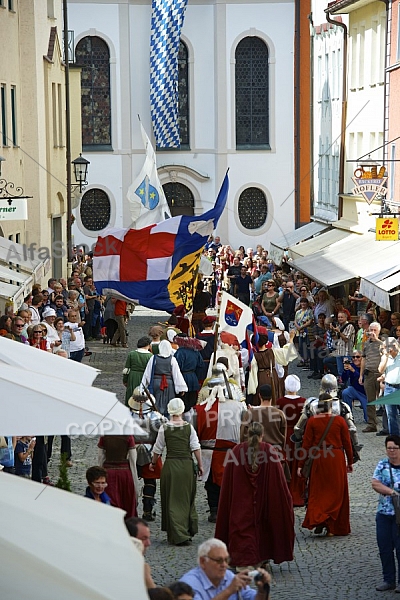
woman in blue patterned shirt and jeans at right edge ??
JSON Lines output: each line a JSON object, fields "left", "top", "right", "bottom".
{"left": 372, "top": 435, "right": 400, "bottom": 592}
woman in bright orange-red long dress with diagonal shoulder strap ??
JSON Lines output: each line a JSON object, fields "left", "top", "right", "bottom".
{"left": 298, "top": 394, "right": 353, "bottom": 536}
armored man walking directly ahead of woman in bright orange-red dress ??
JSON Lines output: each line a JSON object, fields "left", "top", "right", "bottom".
{"left": 292, "top": 373, "right": 362, "bottom": 458}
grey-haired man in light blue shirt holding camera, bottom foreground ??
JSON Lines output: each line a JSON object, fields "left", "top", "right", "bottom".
{"left": 180, "top": 538, "right": 271, "bottom": 600}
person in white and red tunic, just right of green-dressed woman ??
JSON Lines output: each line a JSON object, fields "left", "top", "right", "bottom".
{"left": 193, "top": 362, "right": 246, "bottom": 523}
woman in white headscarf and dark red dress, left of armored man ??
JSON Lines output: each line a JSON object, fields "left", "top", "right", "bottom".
{"left": 276, "top": 375, "right": 306, "bottom": 506}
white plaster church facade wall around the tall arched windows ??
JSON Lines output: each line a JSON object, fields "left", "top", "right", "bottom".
{"left": 69, "top": 1, "right": 294, "bottom": 246}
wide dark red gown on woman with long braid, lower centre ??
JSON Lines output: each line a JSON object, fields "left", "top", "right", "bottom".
{"left": 215, "top": 442, "right": 295, "bottom": 567}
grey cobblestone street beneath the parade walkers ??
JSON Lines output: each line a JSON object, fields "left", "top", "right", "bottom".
{"left": 50, "top": 307, "right": 385, "bottom": 600}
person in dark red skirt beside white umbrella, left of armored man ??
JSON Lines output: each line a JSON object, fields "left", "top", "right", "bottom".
{"left": 98, "top": 435, "right": 137, "bottom": 519}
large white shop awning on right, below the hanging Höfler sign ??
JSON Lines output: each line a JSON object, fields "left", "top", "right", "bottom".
{"left": 292, "top": 233, "right": 400, "bottom": 294}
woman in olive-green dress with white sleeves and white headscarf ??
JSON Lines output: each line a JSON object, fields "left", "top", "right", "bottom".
{"left": 149, "top": 398, "right": 203, "bottom": 546}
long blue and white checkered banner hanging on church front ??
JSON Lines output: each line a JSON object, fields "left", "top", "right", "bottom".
{"left": 150, "top": 0, "right": 187, "bottom": 148}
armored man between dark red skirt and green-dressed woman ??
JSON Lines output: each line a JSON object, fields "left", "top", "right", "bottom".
{"left": 128, "top": 387, "right": 168, "bottom": 521}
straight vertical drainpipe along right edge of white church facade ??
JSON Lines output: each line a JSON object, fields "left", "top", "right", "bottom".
{"left": 294, "top": 0, "right": 301, "bottom": 228}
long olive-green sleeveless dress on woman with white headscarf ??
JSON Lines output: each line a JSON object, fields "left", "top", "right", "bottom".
{"left": 160, "top": 423, "right": 200, "bottom": 545}
